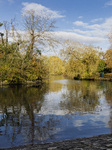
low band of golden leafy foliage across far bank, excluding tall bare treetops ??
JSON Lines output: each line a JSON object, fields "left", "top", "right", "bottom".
{"left": 0, "top": 41, "right": 112, "bottom": 84}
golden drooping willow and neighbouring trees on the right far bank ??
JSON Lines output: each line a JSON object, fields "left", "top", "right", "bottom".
{"left": 61, "top": 41, "right": 112, "bottom": 79}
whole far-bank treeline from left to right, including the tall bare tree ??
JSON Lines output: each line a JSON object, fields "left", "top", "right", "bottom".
{"left": 0, "top": 11, "right": 112, "bottom": 84}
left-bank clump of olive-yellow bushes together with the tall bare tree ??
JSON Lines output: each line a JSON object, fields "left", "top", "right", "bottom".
{"left": 0, "top": 10, "right": 55, "bottom": 84}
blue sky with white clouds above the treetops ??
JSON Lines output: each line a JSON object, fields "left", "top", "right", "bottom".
{"left": 0, "top": 0, "right": 112, "bottom": 54}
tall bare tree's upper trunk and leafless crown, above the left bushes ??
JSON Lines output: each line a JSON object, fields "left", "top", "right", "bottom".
{"left": 23, "top": 10, "right": 55, "bottom": 59}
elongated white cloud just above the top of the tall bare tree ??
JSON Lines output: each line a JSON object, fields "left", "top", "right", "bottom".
{"left": 22, "top": 2, "right": 64, "bottom": 19}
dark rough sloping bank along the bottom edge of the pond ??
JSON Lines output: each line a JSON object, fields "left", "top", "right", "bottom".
{"left": 1, "top": 134, "right": 112, "bottom": 150}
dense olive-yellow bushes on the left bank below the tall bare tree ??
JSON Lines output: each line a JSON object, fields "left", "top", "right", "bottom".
{"left": 0, "top": 43, "right": 47, "bottom": 84}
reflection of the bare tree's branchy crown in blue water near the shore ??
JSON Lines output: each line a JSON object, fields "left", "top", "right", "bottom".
{"left": 24, "top": 115, "right": 60, "bottom": 143}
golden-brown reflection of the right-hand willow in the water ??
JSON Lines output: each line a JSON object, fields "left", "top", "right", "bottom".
{"left": 60, "top": 81, "right": 99, "bottom": 112}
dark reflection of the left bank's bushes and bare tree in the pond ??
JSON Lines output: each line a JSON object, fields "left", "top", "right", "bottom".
{"left": 0, "top": 86, "right": 60, "bottom": 147}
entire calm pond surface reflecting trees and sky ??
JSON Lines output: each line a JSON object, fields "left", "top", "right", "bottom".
{"left": 0, "top": 77, "right": 112, "bottom": 148}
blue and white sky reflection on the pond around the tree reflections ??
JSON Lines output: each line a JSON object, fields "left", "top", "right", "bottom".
{"left": 0, "top": 79, "right": 111, "bottom": 147}
